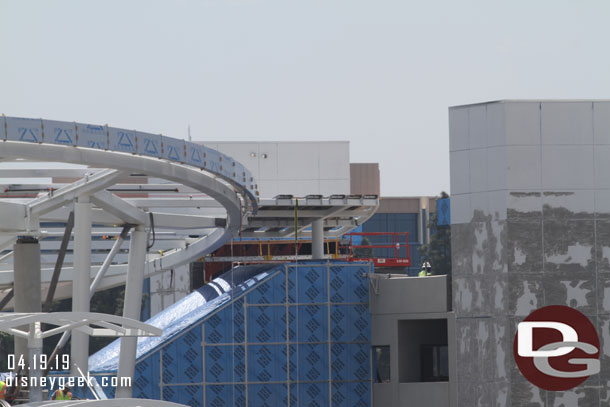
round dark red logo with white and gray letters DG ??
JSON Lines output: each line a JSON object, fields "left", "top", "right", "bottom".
{"left": 513, "top": 305, "right": 600, "bottom": 391}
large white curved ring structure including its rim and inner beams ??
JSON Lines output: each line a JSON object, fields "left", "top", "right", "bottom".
{"left": 0, "top": 116, "right": 258, "bottom": 300}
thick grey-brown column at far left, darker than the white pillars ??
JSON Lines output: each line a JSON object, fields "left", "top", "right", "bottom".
{"left": 13, "top": 236, "right": 42, "bottom": 372}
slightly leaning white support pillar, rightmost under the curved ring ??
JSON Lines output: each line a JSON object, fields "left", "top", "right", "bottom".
{"left": 116, "top": 226, "right": 147, "bottom": 398}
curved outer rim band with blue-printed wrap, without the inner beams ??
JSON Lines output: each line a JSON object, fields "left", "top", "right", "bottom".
{"left": 0, "top": 116, "right": 258, "bottom": 280}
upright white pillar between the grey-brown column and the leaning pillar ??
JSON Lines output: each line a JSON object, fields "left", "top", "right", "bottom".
{"left": 70, "top": 196, "right": 91, "bottom": 376}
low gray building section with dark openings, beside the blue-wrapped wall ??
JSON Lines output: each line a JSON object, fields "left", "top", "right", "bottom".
{"left": 370, "top": 274, "right": 457, "bottom": 407}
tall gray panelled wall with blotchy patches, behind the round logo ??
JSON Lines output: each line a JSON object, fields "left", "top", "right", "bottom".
{"left": 449, "top": 101, "right": 610, "bottom": 407}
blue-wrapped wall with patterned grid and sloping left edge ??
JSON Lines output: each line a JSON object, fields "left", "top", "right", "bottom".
{"left": 89, "top": 261, "right": 372, "bottom": 407}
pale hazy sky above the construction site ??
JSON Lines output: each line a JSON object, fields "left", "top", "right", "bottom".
{"left": 0, "top": 0, "right": 610, "bottom": 196}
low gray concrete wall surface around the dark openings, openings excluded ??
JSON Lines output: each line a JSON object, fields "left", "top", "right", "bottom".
{"left": 371, "top": 274, "right": 456, "bottom": 407}
